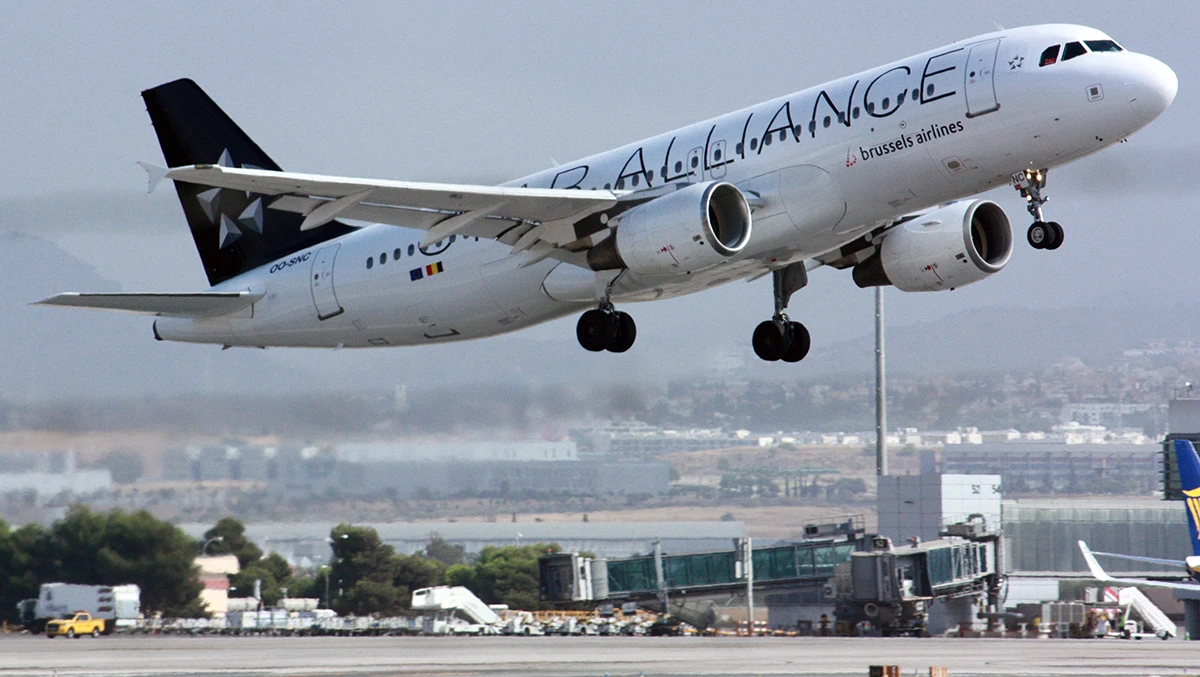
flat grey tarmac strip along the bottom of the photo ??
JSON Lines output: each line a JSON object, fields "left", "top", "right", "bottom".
{"left": 0, "top": 635, "right": 1200, "bottom": 677}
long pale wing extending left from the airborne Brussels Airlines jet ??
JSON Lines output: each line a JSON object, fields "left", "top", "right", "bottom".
{"left": 166, "top": 164, "right": 631, "bottom": 264}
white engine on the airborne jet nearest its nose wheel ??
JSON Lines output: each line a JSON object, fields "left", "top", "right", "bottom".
{"left": 854, "top": 199, "right": 1013, "bottom": 292}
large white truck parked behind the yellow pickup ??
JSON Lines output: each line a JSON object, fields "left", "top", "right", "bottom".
{"left": 17, "top": 583, "right": 142, "bottom": 634}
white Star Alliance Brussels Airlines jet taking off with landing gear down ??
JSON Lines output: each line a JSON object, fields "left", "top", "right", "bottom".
{"left": 37, "top": 24, "right": 1178, "bottom": 363}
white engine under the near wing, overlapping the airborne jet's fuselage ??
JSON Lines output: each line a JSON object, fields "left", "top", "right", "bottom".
{"left": 593, "top": 181, "right": 751, "bottom": 275}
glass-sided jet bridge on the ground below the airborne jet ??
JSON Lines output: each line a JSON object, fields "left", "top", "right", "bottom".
{"left": 539, "top": 520, "right": 1000, "bottom": 634}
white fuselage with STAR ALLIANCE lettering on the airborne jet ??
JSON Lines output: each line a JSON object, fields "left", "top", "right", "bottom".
{"left": 156, "top": 25, "right": 1175, "bottom": 347}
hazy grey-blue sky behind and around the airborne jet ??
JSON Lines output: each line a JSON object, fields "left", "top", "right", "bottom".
{"left": 0, "top": 0, "right": 1200, "bottom": 393}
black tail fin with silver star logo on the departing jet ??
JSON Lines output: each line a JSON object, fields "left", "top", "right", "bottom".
{"left": 142, "top": 79, "right": 353, "bottom": 284}
